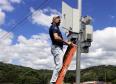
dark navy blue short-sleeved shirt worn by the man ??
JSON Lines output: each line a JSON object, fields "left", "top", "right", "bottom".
{"left": 49, "top": 24, "right": 63, "bottom": 48}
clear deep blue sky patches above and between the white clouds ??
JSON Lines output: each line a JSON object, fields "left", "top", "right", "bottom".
{"left": 2, "top": 0, "right": 116, "bottom": 38}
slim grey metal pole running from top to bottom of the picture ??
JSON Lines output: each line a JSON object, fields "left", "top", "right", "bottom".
{"left": 76, "top": 0, "right": 82, "bottom": 84}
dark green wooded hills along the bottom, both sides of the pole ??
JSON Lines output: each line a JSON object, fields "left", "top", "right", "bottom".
{"left": 0, "top": 62, "right": 116, "bottom": 84}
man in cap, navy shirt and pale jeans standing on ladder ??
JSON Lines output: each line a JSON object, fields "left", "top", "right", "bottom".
{"left": 49, "top": 16, "right": 72, "bottom": 84}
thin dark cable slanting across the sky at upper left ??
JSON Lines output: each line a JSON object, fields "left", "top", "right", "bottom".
{"left": 0, "top": 0, "right": 49, "bottom": 40}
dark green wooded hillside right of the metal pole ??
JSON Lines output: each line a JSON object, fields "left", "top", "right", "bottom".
{"left": 81, "top": 65, "right": 116, "bottom": 84}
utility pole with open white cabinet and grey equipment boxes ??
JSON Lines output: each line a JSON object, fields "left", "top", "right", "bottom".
{"left": 62, "top": 0, "right": 93, "bottom": 84}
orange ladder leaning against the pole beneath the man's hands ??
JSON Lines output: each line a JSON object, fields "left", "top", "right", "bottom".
{"left": 56, "top": 45, "right": 77, "bottom": 84}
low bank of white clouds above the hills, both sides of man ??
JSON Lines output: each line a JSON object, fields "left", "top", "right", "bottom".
{"left": 0, "top": 27, "right": 116, "bottom": 69}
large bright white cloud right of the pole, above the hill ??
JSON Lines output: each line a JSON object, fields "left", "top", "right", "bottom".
{"left": 81, "top": 27, "right": 116, "bottom": 68}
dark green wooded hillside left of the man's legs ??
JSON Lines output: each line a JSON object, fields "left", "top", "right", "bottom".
{"left": 0, "top": 63, "right": 52, "bottom": 84}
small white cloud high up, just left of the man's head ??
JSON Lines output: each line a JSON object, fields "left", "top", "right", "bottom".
{"left": 30, "top": 8, "right": 60, "bottom": 27}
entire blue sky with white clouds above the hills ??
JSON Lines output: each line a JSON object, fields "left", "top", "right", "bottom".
{"left": 0, "top": 0, "right": 116, "bottom": 70}
